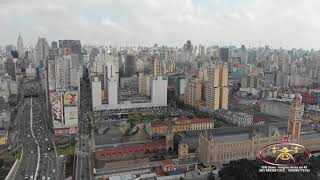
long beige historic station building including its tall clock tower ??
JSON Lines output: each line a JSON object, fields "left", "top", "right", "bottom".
{"left": 197, "top": 96, "right": 320, "bottom": 164}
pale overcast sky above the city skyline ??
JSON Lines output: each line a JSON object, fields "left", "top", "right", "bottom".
{"left": 0, "top": 0, "right": 320, "bottom": 49}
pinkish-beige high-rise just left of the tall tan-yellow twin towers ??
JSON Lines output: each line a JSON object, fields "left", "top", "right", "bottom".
{"left": 184, "top": 79, "right": 202, "bottom": 107}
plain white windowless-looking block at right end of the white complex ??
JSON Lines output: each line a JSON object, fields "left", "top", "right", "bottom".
{"left": 151, "top": 76, "right": 168, "bottom": 106}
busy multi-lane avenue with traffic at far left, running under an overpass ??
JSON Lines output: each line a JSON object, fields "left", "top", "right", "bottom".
{"left": 14, "top": 82, "right": 61, "bottom": 180}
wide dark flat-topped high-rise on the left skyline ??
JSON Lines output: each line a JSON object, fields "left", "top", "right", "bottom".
{"left": 59, "top": 40, "right": 81, "bottom": 57}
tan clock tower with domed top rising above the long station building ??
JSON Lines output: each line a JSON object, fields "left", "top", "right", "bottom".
{"left": 288, "top": 95, "right": 303, "bottom": 141}
